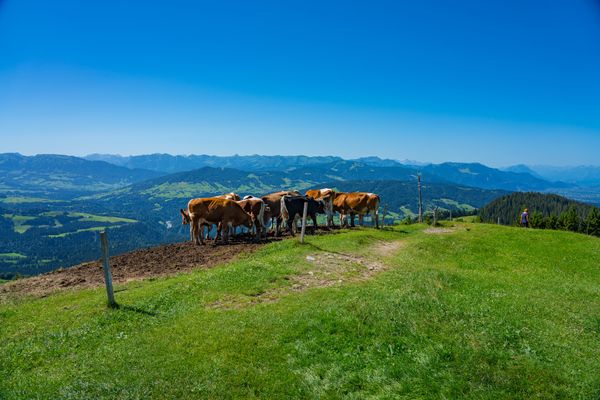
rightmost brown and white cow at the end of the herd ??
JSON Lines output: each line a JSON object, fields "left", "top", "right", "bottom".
{"left": 333, "top": 192, "right": 380, "bottom": 228}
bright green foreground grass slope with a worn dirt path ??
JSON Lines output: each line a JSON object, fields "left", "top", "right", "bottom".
{"left": 0, "top": 223, "right": 600, "bottom": 399}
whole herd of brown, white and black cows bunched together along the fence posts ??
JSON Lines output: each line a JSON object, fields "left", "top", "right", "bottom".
{"left": 179, "top": 189, "right": 380, "bottom": 244}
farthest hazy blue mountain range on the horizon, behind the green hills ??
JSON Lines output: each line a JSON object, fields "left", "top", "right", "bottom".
{"left": 86, "top": 154, "right": 570, "bottom": 190}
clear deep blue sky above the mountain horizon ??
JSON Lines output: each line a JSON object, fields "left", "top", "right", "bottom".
{"left": 0, "top": 0, "right": 600, "bottom": 166}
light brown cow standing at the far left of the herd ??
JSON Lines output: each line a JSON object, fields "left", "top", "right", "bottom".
{"left": 179, "top": 197, "right": 253, "bottom": 244}
